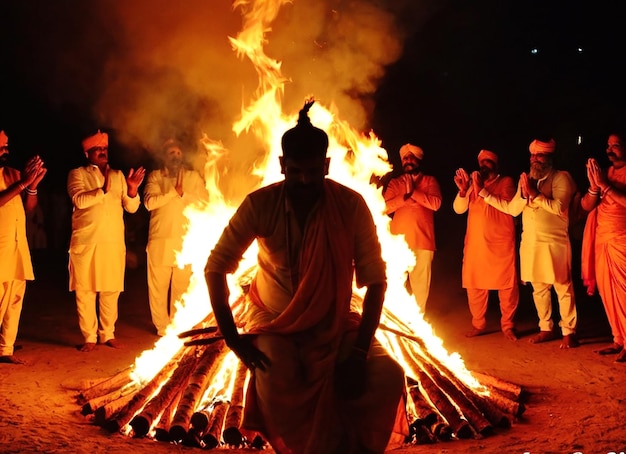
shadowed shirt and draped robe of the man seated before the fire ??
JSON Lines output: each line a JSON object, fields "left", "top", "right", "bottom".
{"left": 206, "top": 179, "right": 404, "bottom": 454}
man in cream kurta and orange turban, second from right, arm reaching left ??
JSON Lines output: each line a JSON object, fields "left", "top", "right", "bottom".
{"left": 484, "top": 139, "right": 578, "bottom": 348}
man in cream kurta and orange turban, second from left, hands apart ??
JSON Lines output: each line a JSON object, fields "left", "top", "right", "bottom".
{"left": 67, "top": 131, "right": 145, "bottom": 352}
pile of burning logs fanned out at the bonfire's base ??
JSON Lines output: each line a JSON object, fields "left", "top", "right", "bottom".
{"left": 78, "top": 298, "right": 524, "bottom": 449}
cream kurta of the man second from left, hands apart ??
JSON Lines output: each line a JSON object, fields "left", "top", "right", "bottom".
{"left": 67, "top": 165, "right": 140, "bottom": 292}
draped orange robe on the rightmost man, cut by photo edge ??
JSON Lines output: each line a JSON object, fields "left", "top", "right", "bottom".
{"left": 582, "top": 167, "right": 626, "bottom": 345}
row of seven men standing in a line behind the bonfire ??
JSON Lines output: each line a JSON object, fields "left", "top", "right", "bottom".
{"left": 0, "top": 127, "right": 626, "bottom": 362}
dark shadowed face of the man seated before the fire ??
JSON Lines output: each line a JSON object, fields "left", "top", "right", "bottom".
{"left": 279, "top": 156, "right": 330, "bottom": 201}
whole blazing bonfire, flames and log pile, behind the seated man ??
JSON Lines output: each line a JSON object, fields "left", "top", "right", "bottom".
{"left": 78, "top": 1, "right": 524, "bottom": 448}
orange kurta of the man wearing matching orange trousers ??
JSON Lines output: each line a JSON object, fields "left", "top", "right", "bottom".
{"left": 454, "top": 176, "right": 517, "bottom": 289}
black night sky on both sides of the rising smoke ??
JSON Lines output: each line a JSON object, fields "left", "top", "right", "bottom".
{"left": 0, "top": 0, "right": 626, "bottom": 195}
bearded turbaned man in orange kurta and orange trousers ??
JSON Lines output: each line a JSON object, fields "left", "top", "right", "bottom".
{"left": 453, "top": 150, "right": 519, "bottom": 341}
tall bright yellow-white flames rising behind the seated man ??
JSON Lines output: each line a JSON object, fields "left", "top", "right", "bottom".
{"left": 133, "top": 0, "right": 485, "bottom": 418}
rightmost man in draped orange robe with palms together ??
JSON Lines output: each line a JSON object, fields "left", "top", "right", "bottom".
{"left": 581, "top": 132, "right": 626, "bottom": 362}
